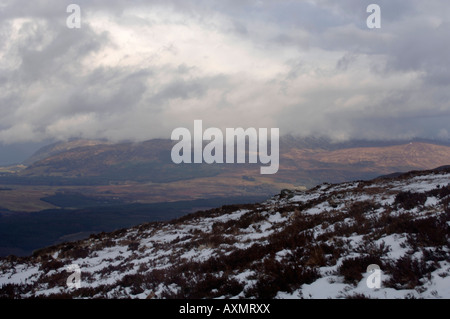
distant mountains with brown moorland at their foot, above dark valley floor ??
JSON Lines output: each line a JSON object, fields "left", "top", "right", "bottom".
{"left": 0, "top": 136, "right": 450, "bottom": 211}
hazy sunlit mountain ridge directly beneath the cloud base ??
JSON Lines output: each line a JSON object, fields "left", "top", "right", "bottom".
{"left": 14, "top": 137, "right": 450, "bottom": 182}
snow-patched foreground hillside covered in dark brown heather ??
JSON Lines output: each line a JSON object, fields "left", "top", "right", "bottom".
{"left": 0, "top": 167, "right": 450, "bottom": 298}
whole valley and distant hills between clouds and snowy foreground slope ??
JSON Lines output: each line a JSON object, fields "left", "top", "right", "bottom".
{"left": 0, "top": 137, "right": 450, "bottom": 256}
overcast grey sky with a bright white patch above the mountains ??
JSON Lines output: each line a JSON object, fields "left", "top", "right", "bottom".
{"left": 0, "top": 0, "right": 450, "bottom": 162}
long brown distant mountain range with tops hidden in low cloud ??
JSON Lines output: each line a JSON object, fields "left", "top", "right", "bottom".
{"left": 20, "top": 137, "right": 450, "bottom": 182}
